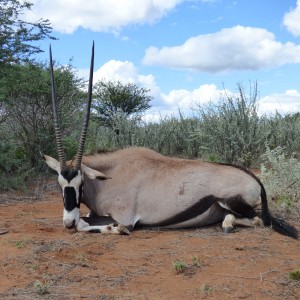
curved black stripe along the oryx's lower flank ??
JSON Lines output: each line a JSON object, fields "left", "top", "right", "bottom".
{"left": 151, "top": 195, "right": 218, "bottom": 226}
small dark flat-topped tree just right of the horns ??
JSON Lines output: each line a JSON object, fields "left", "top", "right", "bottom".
{"left": 92, "top": 81, "right": 152, "bottom": 127}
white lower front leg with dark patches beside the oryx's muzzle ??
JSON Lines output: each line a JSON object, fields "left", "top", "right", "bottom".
{"left": 76, "top": 219, "right": 130, "bottom": 235}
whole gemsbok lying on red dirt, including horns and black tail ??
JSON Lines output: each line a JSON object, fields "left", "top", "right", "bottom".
{"left": 44, "top": 45, "right": 298, "bottom": 238}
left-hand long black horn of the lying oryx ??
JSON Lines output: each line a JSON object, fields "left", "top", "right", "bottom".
{"left": 50, "top": 45, "right": 66, "bottom": 169}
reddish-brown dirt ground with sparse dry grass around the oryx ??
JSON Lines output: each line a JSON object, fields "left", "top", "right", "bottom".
{"left": 0, "top": 186, "right": 300, "bottom": 300}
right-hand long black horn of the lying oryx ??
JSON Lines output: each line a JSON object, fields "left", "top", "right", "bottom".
{"left": 75, "top": 42, "right": 94, "bottom": 170}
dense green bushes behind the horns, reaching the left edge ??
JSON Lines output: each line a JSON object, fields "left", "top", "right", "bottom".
{"left": 0, "top": 63, "right": 86, "bottom": 190}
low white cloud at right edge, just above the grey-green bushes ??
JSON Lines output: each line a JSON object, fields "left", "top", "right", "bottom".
{"left": 258, "top": 90, "right": 300, "bottom": 115}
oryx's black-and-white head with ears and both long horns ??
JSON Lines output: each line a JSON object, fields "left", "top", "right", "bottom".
{"left": 44, "top": 43, "right": 107, "bottom": 229}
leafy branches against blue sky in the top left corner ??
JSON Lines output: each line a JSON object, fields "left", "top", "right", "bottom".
{"left": 0, "top": 0, "right": 54, "bottom": 67}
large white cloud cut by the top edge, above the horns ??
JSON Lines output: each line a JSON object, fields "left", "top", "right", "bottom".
{"left": 26, "top": 0, "right": 184, "bottom": 33}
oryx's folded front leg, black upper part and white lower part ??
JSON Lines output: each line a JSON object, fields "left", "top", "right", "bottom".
{"left": 76, "top": 217, "right": 130, "bottom": 235}
